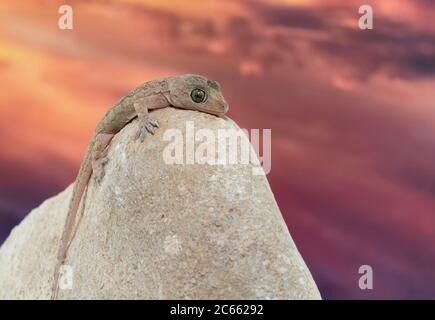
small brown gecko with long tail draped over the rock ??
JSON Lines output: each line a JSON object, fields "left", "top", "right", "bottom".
{"left": 52, "top": 74, "right": 229, "bottom": 299}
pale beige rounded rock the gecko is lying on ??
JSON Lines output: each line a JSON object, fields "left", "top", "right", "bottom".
{"left": 0, "top": 108, "right": 320, "bottom": 299}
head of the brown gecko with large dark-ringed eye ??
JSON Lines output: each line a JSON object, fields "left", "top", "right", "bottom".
{"left": 168, "top": 74, "right": 228, "bottom": 116}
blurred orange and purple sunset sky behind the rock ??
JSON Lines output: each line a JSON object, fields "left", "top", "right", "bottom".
{"left": 0, "top": 0, "right": 435, "bottom": 299}
